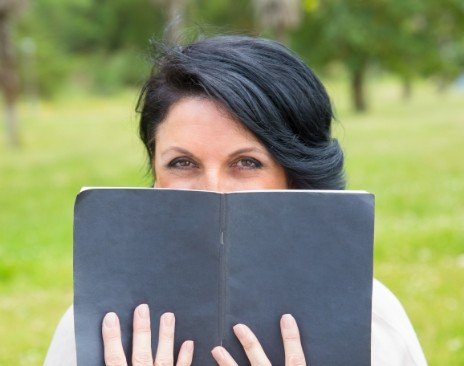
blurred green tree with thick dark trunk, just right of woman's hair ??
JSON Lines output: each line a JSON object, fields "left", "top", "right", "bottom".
{"left": 299, "top": 0, "right": 408, "bottom": 111}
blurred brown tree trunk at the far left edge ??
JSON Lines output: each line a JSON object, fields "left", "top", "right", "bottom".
{"left": 0, "top": 0, "right": 24, "bottom": 145}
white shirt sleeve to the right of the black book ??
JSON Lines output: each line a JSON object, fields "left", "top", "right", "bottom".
{"left": 371, "top": 280, "right": 427, "bottom": 366}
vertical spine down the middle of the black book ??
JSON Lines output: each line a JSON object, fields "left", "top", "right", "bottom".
{"left": 218, "top": 194, "right": 227, "bottom": 346}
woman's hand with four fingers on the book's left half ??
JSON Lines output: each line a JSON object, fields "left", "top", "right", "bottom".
{"left": 102, "top": 304, "right": 193, "bottom": 366}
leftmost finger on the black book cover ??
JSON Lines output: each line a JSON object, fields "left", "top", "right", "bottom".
{"left": 102, "top": 313, "right": 127, "bottom": 366}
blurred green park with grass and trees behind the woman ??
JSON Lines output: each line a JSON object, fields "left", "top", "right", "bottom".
{"left": 0, "top": 0, "right": 464, "bottom": 366}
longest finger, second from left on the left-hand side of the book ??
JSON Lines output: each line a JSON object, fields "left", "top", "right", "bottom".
{"left": 132, "top": 304, "right": 153, "bottom": 366}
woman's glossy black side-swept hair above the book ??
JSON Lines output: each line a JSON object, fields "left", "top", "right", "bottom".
{"left": 137, "top": 36, "right": 345, "bottom": 189}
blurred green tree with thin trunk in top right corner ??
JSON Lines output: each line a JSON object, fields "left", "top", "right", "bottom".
{"left": 382, "top": 0, "right": 464, "bottom": 98}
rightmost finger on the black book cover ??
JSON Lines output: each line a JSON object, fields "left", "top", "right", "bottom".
{"left": 280, "top": 314, "right": 306, "bottom": 366}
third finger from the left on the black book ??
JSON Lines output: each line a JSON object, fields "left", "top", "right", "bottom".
{"left": 155, "top": 313, "right": 176, "bottom": 366}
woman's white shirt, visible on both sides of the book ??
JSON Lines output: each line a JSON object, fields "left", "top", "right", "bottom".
{"left": 44, "top": 280, "right": 427, "bottom": 366}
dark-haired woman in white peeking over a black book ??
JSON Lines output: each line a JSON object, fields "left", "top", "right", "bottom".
{"left": 45, "top": 37, "right": 426, "bottom": 366}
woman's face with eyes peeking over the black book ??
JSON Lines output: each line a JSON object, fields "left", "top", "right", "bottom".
{"left": 153, "top": 98, "right": 287, "bottom": 192}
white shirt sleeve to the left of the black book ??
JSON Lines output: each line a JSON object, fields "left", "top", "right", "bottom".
{"left": 44, "top": 306, "right": 77, "bottom": 366}
